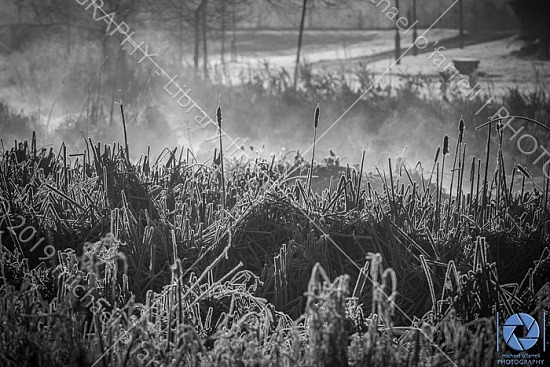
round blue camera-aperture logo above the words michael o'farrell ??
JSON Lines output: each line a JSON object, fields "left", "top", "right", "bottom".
{"left": 502, "top": 313, "right": 540, "bottom": 351}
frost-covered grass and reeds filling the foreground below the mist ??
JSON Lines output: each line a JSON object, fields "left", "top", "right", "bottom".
{"left": 0, "top": 104, "right": 550, "bottom": 366}
